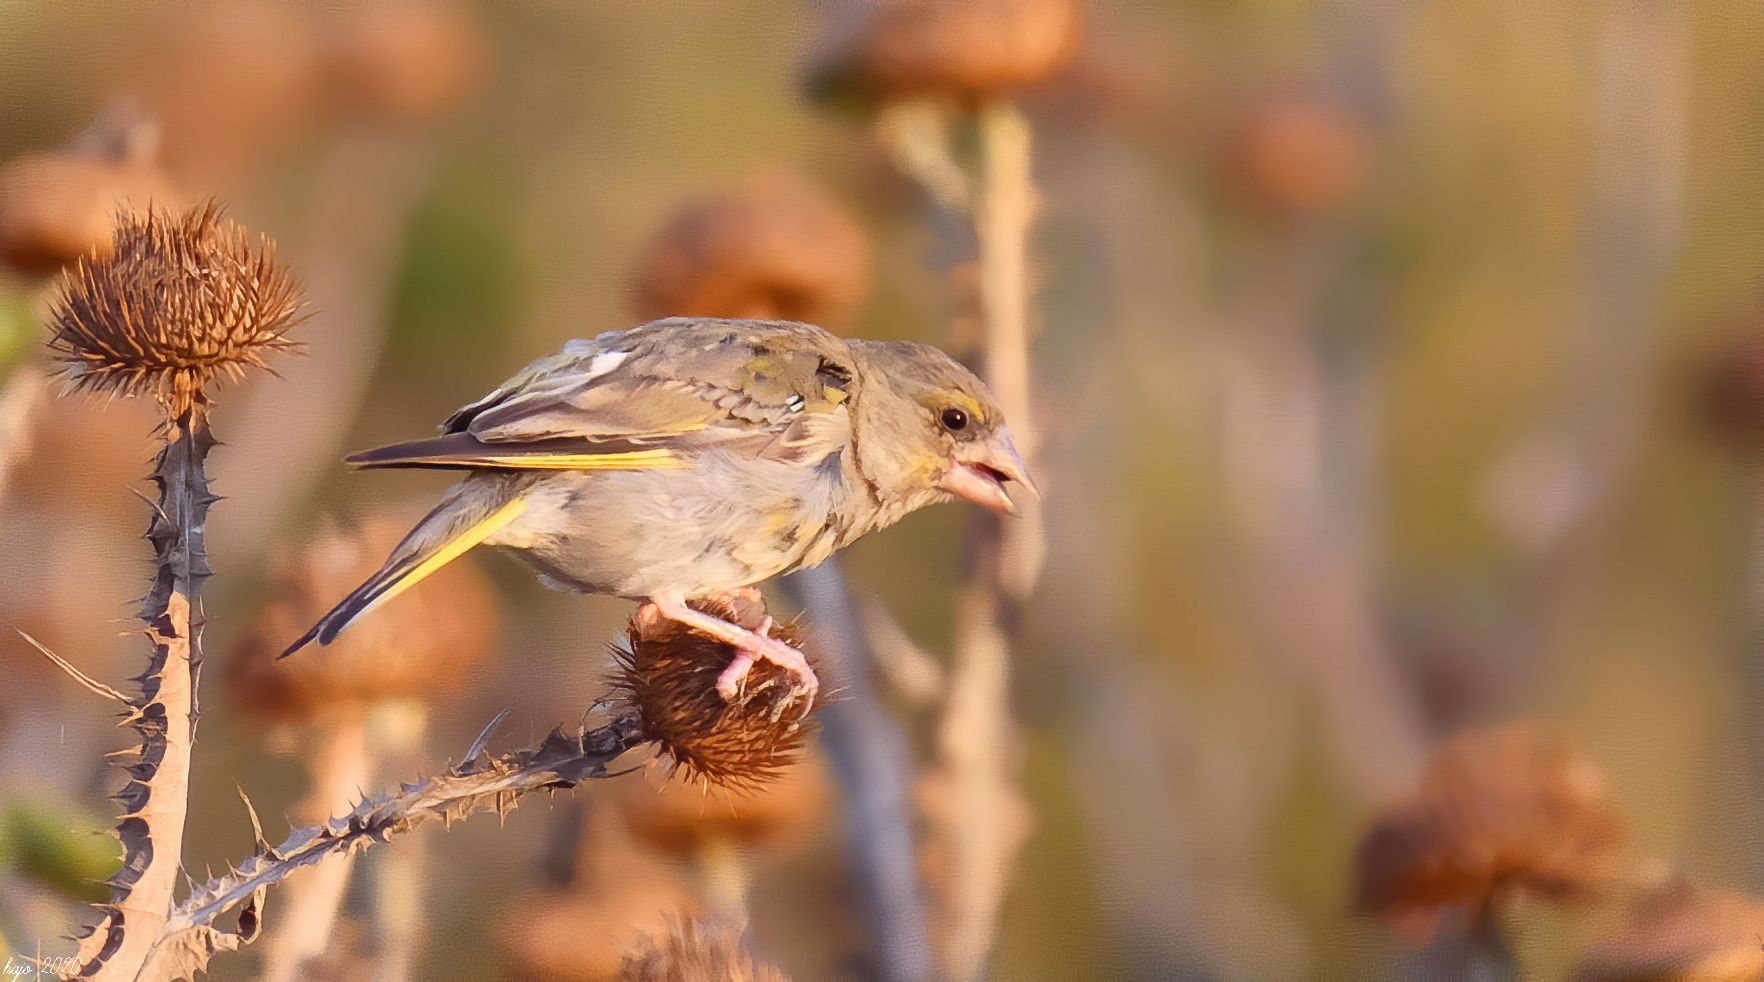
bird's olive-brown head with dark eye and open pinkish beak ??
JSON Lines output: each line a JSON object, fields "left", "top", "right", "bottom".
{"left": 850, "top": 340, "right": 1035, "bottom": 515}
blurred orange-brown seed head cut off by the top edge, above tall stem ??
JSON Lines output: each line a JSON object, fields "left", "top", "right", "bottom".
{"left": 808, "top": 0, "right": 1081, "bottom": 102}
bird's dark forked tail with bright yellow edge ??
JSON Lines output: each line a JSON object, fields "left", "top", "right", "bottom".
{"left": 280, "top": 481, "right": 527, "bottom": 658}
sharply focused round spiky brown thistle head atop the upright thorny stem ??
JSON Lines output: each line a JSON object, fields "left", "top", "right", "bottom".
{"left": 49, "top": 199, "right": 303, "bottom": 414}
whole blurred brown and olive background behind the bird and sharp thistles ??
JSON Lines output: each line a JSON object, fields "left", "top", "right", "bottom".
{"left": 0, "top": 0, "right": 1764, "bottom": 978}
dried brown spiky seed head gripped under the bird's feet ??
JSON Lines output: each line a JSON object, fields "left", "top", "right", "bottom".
{"left": 612, "top": 601, "right": 818, "bottom": 788}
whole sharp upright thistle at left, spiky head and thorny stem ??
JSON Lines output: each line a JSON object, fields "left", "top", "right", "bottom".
{"left": 29, "top": 201, "right": 300, "bottom": 978}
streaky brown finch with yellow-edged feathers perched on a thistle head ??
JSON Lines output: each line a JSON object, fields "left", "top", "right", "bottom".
{"left": 284, "top": 317, "right": 1035, "bottom": 700}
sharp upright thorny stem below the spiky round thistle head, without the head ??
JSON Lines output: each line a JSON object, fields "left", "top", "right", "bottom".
{"left": 78, "top": 395, "right": 215, "bottom": 978}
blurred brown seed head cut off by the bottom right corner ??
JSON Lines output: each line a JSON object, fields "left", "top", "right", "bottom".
{"left": 1573, "top": 883, "right": 1764, "bottom": 982}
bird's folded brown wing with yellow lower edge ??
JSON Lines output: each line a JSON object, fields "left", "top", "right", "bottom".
{"left": 351, "top": 319, "right": 852, "bottom": 469}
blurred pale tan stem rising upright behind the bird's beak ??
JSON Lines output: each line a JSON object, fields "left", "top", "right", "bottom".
{"left": 938, "top": 102, "right": 1043, "bottom": 978}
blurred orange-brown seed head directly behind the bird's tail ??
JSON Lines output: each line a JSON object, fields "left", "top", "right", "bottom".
{"left": 226, "top": 515, "right": 497, "bottom": 721}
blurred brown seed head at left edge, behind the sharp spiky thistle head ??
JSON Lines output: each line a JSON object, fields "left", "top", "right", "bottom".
{"left": 0, "top": 124, "right": 180, "bottom": 275}
